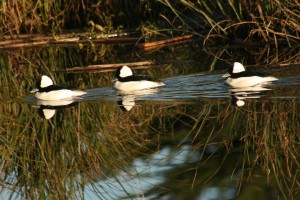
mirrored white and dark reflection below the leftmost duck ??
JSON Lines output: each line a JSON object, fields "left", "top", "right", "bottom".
{"left": 34, "top": 100, "right": 79, "bottom": 120}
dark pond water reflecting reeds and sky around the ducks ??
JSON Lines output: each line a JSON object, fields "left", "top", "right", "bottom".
{"left": 0, "top": 44, "right": 300, "bottom": 200}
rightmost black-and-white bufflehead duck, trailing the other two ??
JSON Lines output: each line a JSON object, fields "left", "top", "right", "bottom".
{"left": 223, "top": 62, "right": 278, "bottom": 88}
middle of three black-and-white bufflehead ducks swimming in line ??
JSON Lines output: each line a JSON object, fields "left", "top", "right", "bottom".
{"left": 115, "top": 66, "right": 165, "bottom": 92}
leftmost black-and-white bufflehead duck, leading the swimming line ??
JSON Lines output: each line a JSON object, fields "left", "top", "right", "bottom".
{"left": 30, "top": 75, "right": 86, "bottom": 100}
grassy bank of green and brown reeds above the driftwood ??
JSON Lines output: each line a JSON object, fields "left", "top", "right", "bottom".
{"left": 0, "top": 0, "right": 300, "bottom": 45}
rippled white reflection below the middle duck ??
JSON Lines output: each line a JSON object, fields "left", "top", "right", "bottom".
{"left": 117, "top": 88, "right": 159, "bottom": 112}
